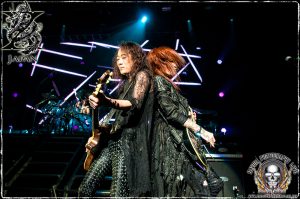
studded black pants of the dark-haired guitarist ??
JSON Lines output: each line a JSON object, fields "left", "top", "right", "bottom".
{"left": 78, "top": 140, "right": 129, "bottom": 197}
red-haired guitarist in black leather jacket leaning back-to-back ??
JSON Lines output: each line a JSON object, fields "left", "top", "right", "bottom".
{"left": 147, "top": 47, "right": 223, "bottom": 197}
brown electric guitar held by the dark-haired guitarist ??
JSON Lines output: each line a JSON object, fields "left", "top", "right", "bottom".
{"left": 83, "top": 70, "right": 112, "bottom": 171}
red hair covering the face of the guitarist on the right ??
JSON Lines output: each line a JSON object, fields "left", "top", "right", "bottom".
{"left": 146, "top": 46, "right": 186, "bottom": 90}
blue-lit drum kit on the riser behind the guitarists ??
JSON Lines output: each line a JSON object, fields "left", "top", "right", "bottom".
{"left": 37, "top": 90, "right": 92, "bottom": 135}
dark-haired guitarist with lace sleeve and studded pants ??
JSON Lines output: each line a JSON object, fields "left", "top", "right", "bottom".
{"left": 78, "top": 42, "right": 153, "bottom": 197}
